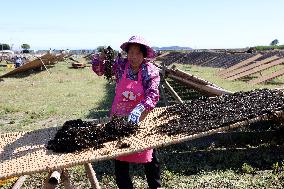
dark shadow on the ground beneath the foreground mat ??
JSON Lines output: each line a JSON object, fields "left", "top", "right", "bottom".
{"left": 93, "top": 122, "right": 284, "bottom": 180}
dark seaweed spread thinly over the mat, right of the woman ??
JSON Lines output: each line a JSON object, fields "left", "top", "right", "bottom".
{"left": 156, "top": 89, "right": 284, "bottom": 136}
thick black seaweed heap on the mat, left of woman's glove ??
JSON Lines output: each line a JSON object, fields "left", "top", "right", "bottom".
{"left": 47, "top": 116, "right": 138, "bottom": 153}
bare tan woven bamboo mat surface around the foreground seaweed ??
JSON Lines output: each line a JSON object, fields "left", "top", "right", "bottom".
{"left": 0, "top": 108, "right": 284, "bottom": 179}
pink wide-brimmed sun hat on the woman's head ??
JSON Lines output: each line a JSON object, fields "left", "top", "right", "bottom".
{"left": 120, "top": 36, "right": 155, "bottom": 58}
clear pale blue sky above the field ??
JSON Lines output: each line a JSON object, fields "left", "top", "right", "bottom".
{"left": 0, "top": 0, "right": 284, "bottom": 49}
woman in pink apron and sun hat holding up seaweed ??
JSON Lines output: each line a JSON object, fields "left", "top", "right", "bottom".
{"left": 92, "top": 36, "right": 161, "bottom": 189}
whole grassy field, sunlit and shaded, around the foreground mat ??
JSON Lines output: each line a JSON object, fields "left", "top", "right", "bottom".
{"left": 0, "top": 62, "right": 284, "bottom": 188}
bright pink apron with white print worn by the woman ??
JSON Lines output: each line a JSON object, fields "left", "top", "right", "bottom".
{"left": 111, "top": 62, "right": 153, "bottom": 163}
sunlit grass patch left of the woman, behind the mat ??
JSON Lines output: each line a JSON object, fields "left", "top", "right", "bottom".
{"left": 0, "top": 62, "right": 114, "bottom": 132}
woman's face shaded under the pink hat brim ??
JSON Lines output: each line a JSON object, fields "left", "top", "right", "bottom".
{"left": 127, "top": 44, "right": 144, "bottom": 67}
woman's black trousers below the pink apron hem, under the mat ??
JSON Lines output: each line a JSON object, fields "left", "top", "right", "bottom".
{"left": 115, "top": 149, "right": 161, "bottom": 189}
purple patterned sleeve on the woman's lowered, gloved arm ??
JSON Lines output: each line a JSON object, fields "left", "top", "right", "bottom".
{"left": 141, "top": 63, "right": 160, "bottom": 111}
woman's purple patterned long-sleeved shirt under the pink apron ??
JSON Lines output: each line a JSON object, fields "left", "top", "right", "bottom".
{"left": 92, "top": 56, "right": 160, "bottom": 111}
